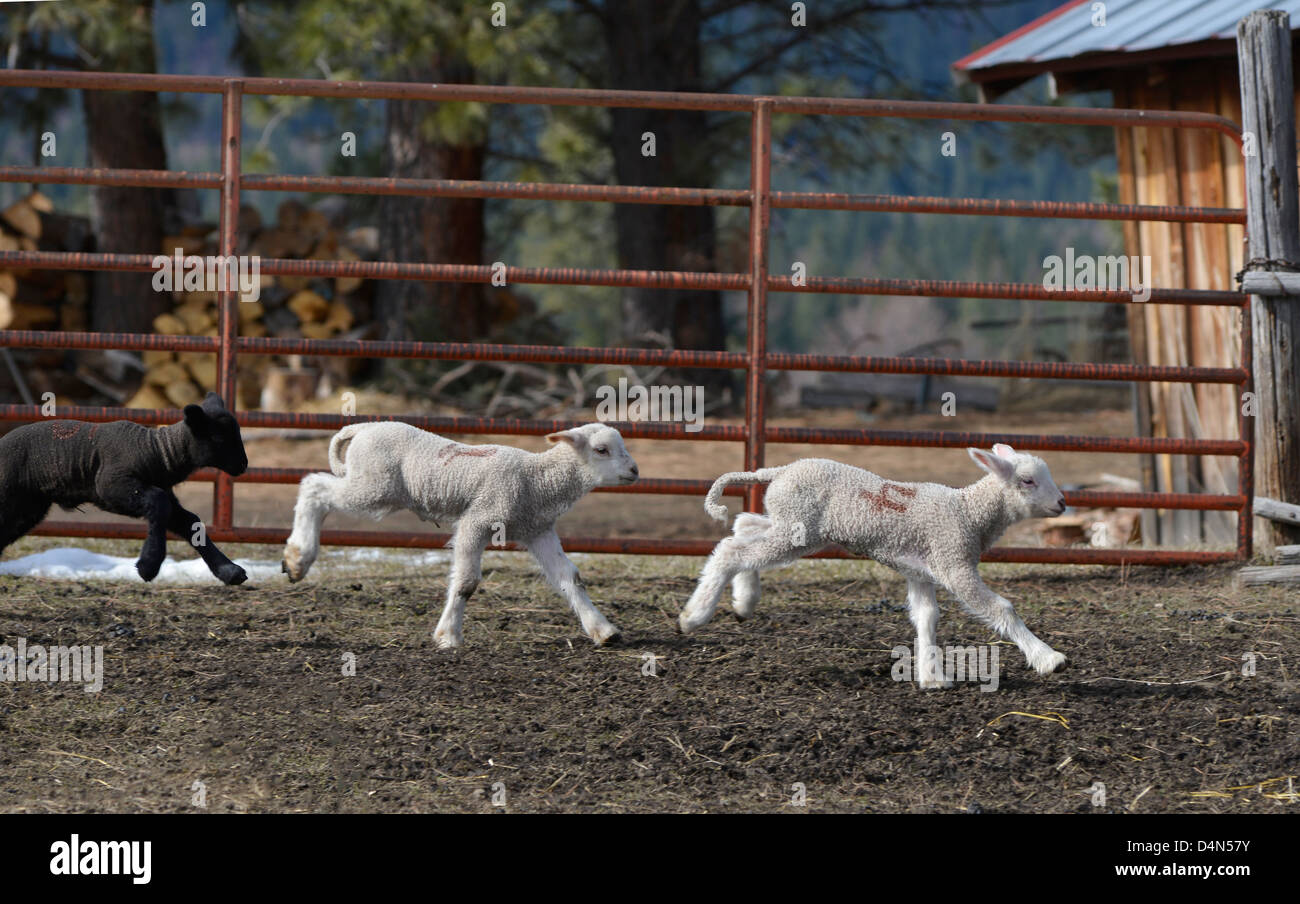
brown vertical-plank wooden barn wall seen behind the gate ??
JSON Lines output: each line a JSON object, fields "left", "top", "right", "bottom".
{"left": 1112, "top": 57, "right": 1244, "bottom": 546}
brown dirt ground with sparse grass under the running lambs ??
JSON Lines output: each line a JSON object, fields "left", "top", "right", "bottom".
{"left": 0, "top": 541, "right": 1300, "bottom": 813}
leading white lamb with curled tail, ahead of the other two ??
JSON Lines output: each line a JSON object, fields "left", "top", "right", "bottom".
{"left": 680, "top": 444, "right": 1065, "bottom": 688}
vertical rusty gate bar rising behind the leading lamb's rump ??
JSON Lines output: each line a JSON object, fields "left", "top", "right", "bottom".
{"left": 745, "top": 98, "right": 772, "bottom": 511}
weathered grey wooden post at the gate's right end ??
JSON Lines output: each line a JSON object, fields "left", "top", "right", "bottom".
{"left": 1236, "top": 9, "right": 1300, "bottom": 553}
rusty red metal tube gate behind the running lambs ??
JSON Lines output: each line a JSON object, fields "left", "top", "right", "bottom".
{"left": 0, "top": 70, "right": 1253, "bottom": 565}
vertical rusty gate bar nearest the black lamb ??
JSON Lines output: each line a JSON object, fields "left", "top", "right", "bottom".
{"left": 212, "top": 78, "right": 243, "bottom": 528}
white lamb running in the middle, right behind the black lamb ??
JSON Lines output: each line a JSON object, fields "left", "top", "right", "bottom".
{"left": 281, "top": 423, "right": 638, "bottom": 649}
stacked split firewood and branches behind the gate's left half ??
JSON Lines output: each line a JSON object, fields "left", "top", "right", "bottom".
{"left": 0, "top": 191, "right": 566, "bottom": 416}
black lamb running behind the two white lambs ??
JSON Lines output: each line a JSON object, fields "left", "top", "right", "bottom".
{"left": 0, "top": 393, "right": 248, "bottom": 584}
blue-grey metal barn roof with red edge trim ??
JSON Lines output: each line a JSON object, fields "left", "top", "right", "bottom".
{"left": 953, "top": 0, "right": 1300, "bottom": 82}
